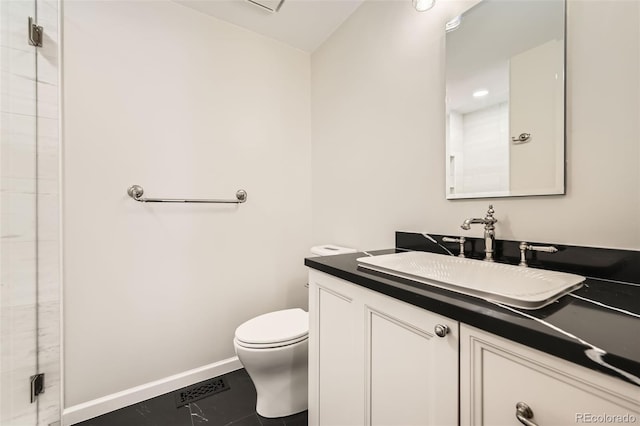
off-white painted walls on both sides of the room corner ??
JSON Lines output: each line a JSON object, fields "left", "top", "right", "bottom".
{"left": 63, "top": 0, "right": 640, "bottom": 414}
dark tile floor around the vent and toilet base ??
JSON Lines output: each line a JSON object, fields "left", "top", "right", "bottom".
{"left": 76, "top": 369, "right": 307, "bottom": 426}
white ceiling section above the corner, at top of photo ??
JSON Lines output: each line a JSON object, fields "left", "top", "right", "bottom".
{"left": 174, "top": 0, "right": 364, "bottom": 52}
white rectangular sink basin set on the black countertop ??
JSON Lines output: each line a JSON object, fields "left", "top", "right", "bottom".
{"left": 358, "top": 251, "right": 585, "bottom": 309}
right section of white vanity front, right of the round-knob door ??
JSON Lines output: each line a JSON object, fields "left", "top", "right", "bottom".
{"left": 460, "top": 324, "right": 640, "bottom": 426}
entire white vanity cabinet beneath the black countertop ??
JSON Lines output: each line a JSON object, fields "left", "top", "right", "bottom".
{"left": 309, "top": 270, "right": 640, "bottom": 426}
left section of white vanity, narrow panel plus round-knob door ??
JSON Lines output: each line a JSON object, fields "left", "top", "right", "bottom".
{"left": 309, "top": 270, "right": 459, "bottom": 426}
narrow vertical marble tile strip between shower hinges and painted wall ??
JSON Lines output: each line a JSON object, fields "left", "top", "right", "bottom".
{"left": 36, "top": 0, "right": 62, "bottom": 426}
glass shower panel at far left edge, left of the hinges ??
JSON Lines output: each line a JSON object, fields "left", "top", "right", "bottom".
{"left": 0, "top": 0, "right": 39, "bottom": 425}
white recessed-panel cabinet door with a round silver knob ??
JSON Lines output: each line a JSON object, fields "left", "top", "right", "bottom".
{"left": 364, "top": 293, "right": 458, "bottom": 426}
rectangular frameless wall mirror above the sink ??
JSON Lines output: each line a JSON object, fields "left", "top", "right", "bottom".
{"left": 446, "top": 0, "right": 565, "bottom": 199}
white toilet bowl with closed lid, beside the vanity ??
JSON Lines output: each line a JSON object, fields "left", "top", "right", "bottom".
{"left": 233, "top": 308, "right": 309, "bottom": 418}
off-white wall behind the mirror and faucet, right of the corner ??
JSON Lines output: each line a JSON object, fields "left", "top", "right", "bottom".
{"left": 311, "top": 0, "right": 640, "bottom": 249}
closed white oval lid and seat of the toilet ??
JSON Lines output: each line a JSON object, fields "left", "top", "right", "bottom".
{"left": 236, "top": 308, "right": 309, "bottom": 343}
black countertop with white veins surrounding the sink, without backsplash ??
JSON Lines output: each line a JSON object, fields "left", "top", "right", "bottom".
{"left": 305, "top": 249, "right": 640, "bottom": 387}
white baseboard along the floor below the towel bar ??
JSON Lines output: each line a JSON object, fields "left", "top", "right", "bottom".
{"left": 62, "top": 357, "right": 242, "bottom": 426}
